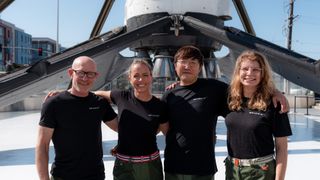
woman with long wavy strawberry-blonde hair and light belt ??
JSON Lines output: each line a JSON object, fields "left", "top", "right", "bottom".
{"left": 225, "top": 50, "right": 292, "bottom": 180}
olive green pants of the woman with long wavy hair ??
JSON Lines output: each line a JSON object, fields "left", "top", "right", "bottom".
{"left": 224, "top": 158, "right": 276, "bottom": 180}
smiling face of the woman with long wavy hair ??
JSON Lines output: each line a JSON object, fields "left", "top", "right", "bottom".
{"left": 240, "top": 59, "right": 262, "bottom": 91}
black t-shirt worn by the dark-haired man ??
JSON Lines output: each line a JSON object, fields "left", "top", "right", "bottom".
{"left": 162, "top": 79, "right": 228, "bottom": 175}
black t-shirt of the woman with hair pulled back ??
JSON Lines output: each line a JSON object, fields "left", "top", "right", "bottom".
{"left": 111, "top": 90, "right": 167, "bottom": 156}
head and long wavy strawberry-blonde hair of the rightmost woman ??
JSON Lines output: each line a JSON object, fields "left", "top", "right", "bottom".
{"left": 229, "top": 50, "right": 275, "bottom": 107}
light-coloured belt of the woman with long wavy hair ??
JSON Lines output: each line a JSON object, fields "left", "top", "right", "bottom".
{"left": 228, "top": 154, "right": 274, "bottom": 166}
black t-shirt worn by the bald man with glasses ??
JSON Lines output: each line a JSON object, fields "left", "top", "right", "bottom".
{"left": 39, "top": 91, "right": 117, "bottom": 180}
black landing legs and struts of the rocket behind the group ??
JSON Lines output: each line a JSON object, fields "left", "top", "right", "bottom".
{"left": 0, "top": 0, "right": 320, "bottom": 106}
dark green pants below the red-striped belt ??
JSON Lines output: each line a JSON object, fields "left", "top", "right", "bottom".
{"left": 113, "top": 157, "right": 163, "bottom": 180}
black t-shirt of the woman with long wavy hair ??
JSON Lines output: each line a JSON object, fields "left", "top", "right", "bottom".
{"left": 225, "top": 103, "right": 292, "bottom": 159}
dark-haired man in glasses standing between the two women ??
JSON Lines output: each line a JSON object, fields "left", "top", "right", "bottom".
{"left": 162, "top": 46, "right": 286, "bottom": 180}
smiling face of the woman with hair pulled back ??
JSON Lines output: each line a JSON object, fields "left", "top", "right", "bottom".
{"left": 129, "top": 63, "right": 152, "bottom": 94}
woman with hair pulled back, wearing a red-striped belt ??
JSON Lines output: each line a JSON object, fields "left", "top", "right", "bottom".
{"left": 95, "top": 59, "right": 169, "bottom": 180}
